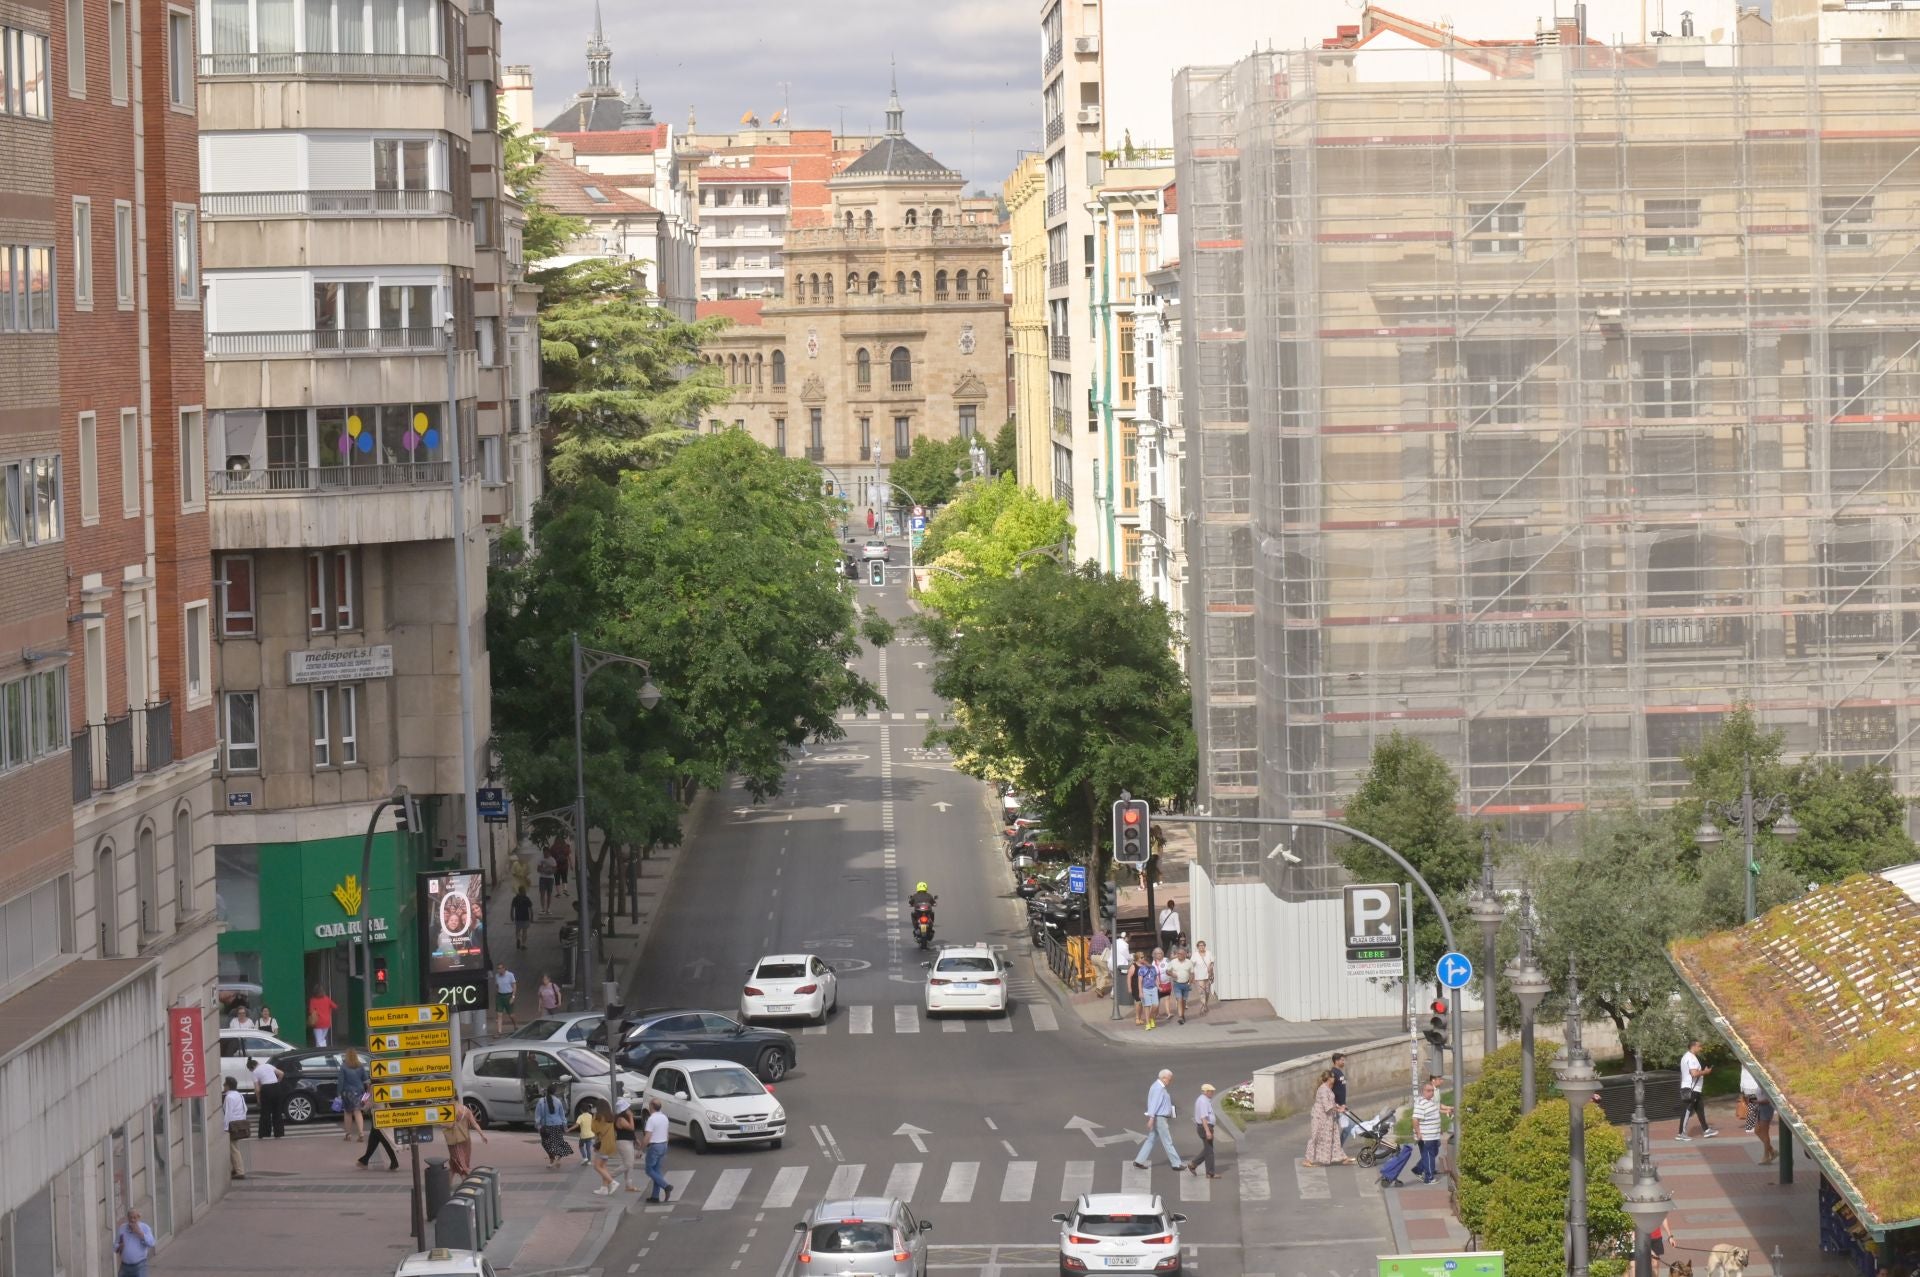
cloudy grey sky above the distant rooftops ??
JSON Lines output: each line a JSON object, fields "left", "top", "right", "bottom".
{"left": 495, "top": 0, "right": 1041, "bottom": 194}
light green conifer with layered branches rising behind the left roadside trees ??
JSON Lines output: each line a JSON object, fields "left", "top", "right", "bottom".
{"left": 532, "top": 259, "right": 732, "bottom": 486}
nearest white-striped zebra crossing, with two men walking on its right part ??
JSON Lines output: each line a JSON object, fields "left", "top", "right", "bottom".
{"left": 637, "top": 1154, "right": 1271, "bottom": 1214}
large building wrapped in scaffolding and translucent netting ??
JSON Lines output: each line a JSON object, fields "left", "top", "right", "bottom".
{"left": 1175, "top": 19, "right": 1920, "bottom": 995}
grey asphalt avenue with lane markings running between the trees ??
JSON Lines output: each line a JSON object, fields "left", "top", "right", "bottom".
{"left": 586, "top": 568, "right": 1332, "bottom": 1273}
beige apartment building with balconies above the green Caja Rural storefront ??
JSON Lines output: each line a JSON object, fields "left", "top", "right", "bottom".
{"left": 200, "top": 0, "right": 491, "bottom": 1037}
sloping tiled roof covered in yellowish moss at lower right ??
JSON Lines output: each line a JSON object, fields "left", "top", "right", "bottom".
{"left": 1672, "top": 866, "right": 1920, "bottom": 1231}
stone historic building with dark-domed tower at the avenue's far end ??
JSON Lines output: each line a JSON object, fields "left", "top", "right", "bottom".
{"left": 701, "top": 94, "right": 1006, "bottom": 515}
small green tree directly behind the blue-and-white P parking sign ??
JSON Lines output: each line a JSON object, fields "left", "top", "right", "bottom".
{"left": 1340, "top": 732, "right": 1480, "bottom": 972}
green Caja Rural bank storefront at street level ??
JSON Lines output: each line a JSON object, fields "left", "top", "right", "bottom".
{"left": 215, "top": 831, "right": 432, "bottom": 1045}
